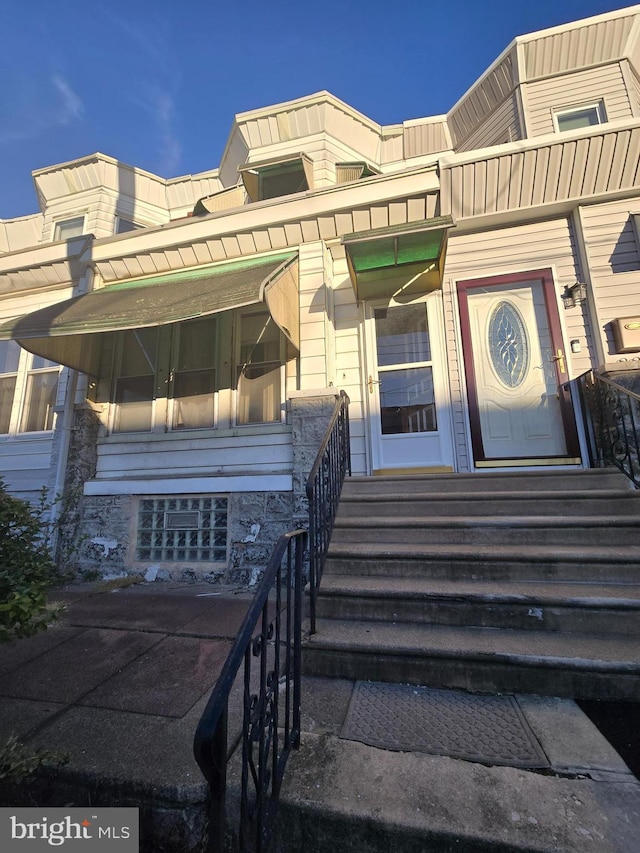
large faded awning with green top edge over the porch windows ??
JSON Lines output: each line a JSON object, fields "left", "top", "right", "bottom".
{"left": 0, "top": 252, "right": 300, "bottom": 376}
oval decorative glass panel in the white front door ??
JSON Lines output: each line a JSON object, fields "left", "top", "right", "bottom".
{"left": 488, "top": 300, "right": 529, "bottom": 388}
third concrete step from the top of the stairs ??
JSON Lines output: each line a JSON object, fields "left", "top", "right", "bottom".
{"left": 331, "top": 506, "right": 640, "bottom": 546}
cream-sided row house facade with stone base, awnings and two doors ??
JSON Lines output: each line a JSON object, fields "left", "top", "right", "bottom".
{"left": 0, "top": 6, "right": 640, "bottom": 583}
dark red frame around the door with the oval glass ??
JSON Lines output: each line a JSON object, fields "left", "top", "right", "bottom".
{"left": 456, "top": 268, "right": 580, "bottom": 467}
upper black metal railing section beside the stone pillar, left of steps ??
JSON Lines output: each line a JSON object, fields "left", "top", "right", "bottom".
{"left": 307, "top": 391, "right": 351, "bottom": 634}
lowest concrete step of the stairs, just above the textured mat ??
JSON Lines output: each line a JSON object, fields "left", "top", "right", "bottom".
{"left": 303, "top": 619, "right": 640, "bottom": 702}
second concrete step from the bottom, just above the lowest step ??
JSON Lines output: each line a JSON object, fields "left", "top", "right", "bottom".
{"left": 317, "top": 575, "right": 640, "bottom": 641}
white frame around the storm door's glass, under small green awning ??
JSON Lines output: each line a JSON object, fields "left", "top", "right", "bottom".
{"left": 362, "top": 291, "right": 454, "bottom": 474}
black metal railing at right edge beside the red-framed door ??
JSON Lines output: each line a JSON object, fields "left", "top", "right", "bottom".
{"left": 577, "top": 370, "right": 640, "bottom": 488}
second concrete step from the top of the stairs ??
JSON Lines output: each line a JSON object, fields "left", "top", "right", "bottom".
{"left": 338, "top": 483, "right": 640, "bottom": 520}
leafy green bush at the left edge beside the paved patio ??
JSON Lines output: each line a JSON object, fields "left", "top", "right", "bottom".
{"left": 0, "top": 480, "right": 57, "bottom": 642}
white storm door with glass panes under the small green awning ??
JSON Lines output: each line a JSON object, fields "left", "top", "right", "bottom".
{"left": 365, "top": 295, "right": 452, "bottom": 471}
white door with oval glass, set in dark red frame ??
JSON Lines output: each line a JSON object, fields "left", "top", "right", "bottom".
{"left": 458, "top": 270, "right": 579, "bottom": 467}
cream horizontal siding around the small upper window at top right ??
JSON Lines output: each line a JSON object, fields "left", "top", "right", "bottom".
{"left": 527, "top": 62, "right": 633, "bottom": 136}
